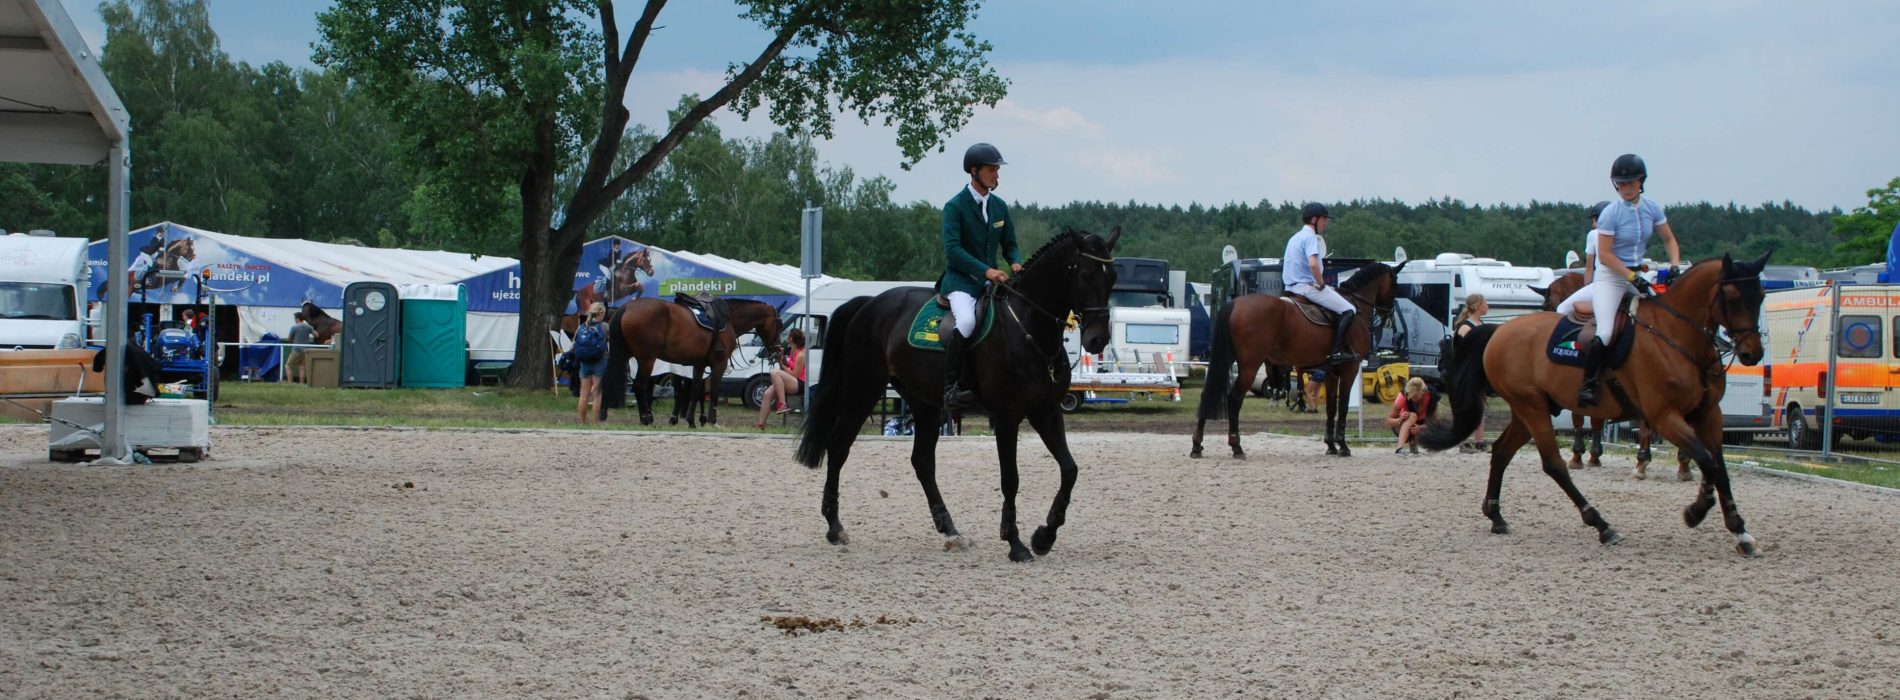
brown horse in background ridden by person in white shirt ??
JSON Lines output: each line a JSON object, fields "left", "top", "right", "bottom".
{"left": 1188, "top": 263, "right": 1406, "bottom": 458}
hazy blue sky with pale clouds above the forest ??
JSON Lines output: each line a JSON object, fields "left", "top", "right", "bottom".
{"left": 63, "top": 0, "right": 1900, "bottom": 209}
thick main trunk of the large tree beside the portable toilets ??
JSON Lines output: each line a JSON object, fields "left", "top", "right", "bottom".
{"left": 507, "top": 118, "right": 581, "bottom": 388}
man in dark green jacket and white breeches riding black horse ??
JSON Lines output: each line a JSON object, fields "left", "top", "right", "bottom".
{"left": 937, "top": 143, "right": 1022, "bottom": 409}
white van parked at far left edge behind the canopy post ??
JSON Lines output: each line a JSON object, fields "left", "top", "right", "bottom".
{"left": 0, "top": 232, "right": 87, "bottom": 350}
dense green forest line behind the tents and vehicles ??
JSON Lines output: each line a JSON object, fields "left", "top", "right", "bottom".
{"left": 0, "top": 0, "right": 1877, "bottom": 287}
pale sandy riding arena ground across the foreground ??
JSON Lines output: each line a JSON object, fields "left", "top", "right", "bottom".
{"left": 0, "top": 426, "right": 1900, "bottom": 698}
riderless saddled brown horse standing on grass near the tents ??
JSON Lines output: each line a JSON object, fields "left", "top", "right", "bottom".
{"left": 600, "top": 299, "right": 779, "bottom": 426}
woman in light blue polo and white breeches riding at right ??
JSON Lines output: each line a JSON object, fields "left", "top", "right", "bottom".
{"left": 1556, "top": 154, "right": 1682, "bottom": 407}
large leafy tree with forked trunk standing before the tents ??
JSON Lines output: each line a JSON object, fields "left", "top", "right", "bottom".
{"left": 315, "top": 0, "right": 1005, "bottom": 386}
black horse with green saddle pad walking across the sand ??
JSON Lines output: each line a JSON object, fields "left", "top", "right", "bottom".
{"left": 798, "top": 228, "right": 1121, "bottom": 561}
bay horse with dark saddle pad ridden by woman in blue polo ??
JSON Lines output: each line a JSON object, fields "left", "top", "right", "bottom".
{"left": 1419, "top": 255, "right": 1767, "bottom": 557}
